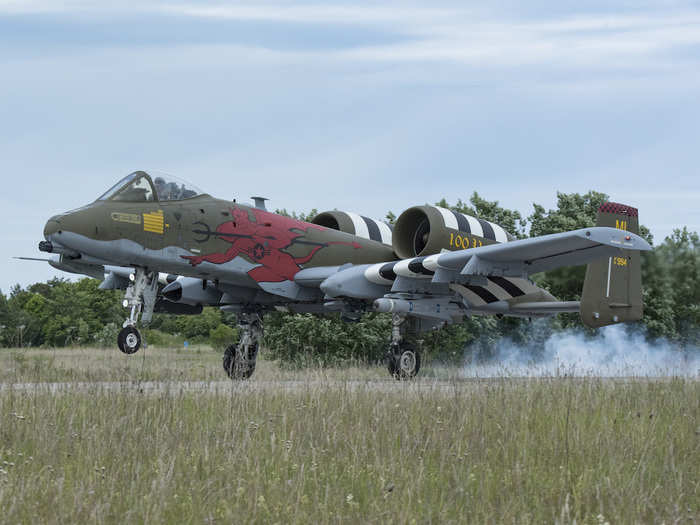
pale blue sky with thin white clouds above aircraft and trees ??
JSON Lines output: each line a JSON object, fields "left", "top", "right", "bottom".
{"left": 0, "top": 0, "right": 700, "bottom": 293}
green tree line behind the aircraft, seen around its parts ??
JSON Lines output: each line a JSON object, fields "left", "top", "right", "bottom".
{"left": 0, "top": 191, "right": 700, "bottom": 365}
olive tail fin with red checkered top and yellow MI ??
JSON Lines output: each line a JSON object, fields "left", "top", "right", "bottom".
{"left": 581, "top": 202, "right": 643, "bottom": 328}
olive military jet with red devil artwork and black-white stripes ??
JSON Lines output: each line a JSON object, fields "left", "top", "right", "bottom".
{"left": 39, "top": 171, "right": 651, "bottom": 379}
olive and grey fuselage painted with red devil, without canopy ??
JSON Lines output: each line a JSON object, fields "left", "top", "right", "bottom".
{"left": 44, "top": 194, "right": 396, "bottom": 286}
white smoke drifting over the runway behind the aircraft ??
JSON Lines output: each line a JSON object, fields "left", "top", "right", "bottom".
{"left": 464, "top": 325, "right": 700, "bottom": 377}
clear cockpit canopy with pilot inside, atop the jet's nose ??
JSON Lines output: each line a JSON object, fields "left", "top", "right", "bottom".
{"left": 98, "top": 171, "right": 203, "bottom": 202}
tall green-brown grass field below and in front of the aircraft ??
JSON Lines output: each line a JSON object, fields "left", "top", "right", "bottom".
{"left": 0, "top": 348, "right": 700, "bottom": 524}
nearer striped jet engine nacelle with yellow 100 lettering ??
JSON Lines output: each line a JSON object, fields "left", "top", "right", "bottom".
{"left": 393, "top": 206, "right": 513, "bottom": 259}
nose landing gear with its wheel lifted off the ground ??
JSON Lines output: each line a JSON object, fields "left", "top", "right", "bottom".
{"left": 117, "top": 268, "right": 158, "bottom": 354}
